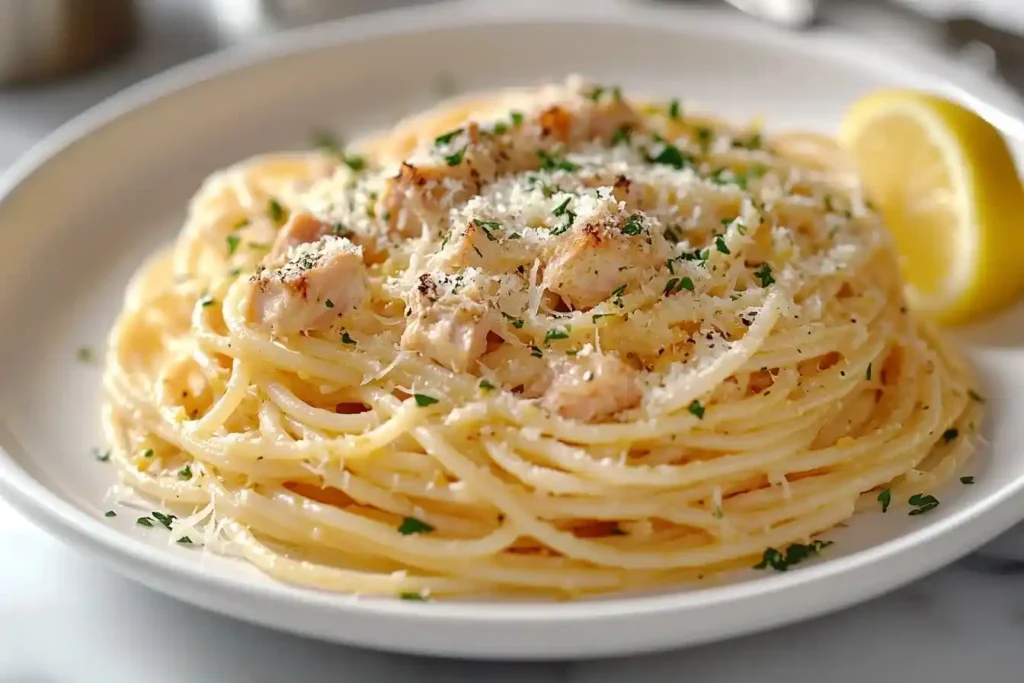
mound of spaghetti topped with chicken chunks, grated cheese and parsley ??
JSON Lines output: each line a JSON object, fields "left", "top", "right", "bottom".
{"left": 103, "top": 79, "right": 979, "bottom": 598}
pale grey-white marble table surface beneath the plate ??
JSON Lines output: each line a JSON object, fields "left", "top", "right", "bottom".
{"left": 0, "top": 0, "right": 1024, "bottom": 683}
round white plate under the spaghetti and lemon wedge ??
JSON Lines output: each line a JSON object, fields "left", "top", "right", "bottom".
{"left": 0, "top": 3, "right": 1024, "bottom": 658}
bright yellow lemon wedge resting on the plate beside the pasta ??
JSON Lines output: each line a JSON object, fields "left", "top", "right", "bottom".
{"left": 839, "top": 90, "right": 1024, "bottom": 325}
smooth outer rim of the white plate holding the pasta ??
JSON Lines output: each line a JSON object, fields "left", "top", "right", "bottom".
{"left": 0, "top": 2, "right": 1024, "bottom": 657}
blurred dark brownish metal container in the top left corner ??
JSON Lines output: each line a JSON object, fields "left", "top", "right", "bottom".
{"left": 0, "top": 0, "right": 135, "bottom": 85}
